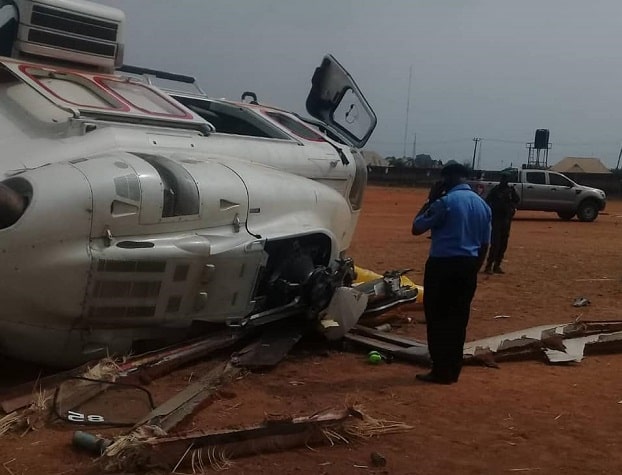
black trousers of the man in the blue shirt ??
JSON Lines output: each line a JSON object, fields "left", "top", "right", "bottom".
{"left": 423, "top": 257, "right": 479, "bottom": 381}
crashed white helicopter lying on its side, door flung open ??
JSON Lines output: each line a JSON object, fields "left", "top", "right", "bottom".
{"left": 0, "top": 0, "right": 416, "bottom": 366}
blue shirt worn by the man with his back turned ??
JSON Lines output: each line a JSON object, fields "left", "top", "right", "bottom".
{"left": 413, "top": 183, "right": 492, "bottom": 257}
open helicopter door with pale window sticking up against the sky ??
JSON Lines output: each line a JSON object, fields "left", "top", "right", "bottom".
{"left": 306, "top": 54, "right": 378, "bottom": 148}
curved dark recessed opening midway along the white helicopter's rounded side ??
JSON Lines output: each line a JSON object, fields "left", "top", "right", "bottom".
{"left": 135, "top": 153, "right": 200, "bottom": 218}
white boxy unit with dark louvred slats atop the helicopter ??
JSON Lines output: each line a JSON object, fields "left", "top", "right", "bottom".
{"left": 16, "top": 0, "right": 125, "bottom": 70}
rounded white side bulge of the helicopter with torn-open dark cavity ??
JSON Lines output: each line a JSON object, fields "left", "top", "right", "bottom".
{"left": 0, "top": 152, "right": 350, "bottom": 366}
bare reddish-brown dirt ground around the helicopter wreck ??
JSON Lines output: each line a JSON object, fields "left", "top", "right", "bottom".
{"left": 0, "top": 187, "right": 622, "bottom": 475}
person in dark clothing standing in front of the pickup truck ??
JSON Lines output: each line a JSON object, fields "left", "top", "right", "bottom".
{"left": 484, "top": 173, "right": 520, "bottom": 274}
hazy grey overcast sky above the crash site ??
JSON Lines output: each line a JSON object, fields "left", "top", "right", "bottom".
{"left": 98, "top": 0, "right": 622, "bottom": 169}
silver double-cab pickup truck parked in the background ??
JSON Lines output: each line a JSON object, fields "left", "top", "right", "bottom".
{"left": 468, "top": 169, "right": 607, "bottom": 222}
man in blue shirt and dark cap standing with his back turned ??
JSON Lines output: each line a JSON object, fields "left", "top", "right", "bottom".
{"left": 412, "top": 163, "right": 491, "bottom": 384}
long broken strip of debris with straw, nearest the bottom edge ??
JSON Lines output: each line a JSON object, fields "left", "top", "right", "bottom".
{"left": 99, "top": 407, "right": 412, "bottom": 472}
